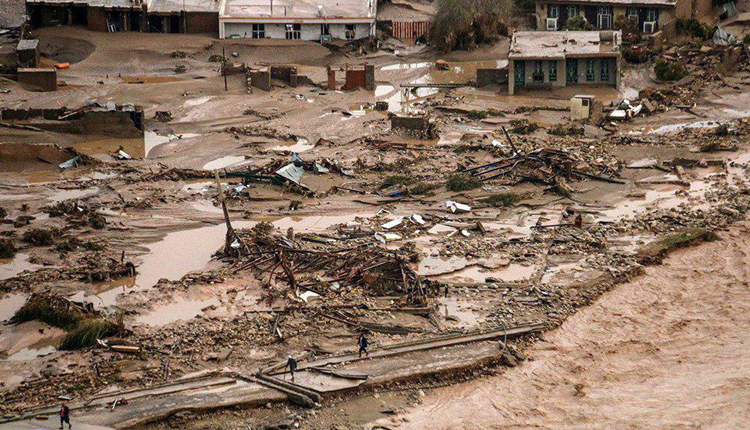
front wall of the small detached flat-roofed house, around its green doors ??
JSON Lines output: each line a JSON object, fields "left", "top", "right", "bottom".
{"left": 508, "top": 58, "right": 620, "bottom": 94}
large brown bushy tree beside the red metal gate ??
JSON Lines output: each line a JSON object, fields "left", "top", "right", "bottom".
{"left": 430, "top": 0, "right": 514, "bottom": 52}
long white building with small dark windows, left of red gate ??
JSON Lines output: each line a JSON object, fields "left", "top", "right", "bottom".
{"left": 219, "top": 0, "right": 378, "bottom": 41}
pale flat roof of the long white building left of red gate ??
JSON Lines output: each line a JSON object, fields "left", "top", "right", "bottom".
{"left": 219, "top": 0, "right": 377, "bottom": 22}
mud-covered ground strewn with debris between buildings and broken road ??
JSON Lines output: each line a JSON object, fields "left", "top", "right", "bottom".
{"left": 0, "top": 23, "right": 750, "bottom": 428}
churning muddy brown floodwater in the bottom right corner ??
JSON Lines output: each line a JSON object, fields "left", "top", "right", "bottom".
{"left": 388, "top": 222, "right": 750, "bottom": 429}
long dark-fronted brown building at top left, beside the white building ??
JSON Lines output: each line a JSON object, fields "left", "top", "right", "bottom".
{"left": 26, "top": 0, "right": 219, "bottom": 35}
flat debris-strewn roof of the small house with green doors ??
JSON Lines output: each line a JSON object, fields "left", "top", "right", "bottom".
{"left": 508, "top": 31, "right": 622, "bottom": 60}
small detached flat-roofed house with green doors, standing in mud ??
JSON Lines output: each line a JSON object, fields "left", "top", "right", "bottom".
{"left": 508, "top": 31, "right": 622, "bottom": 94}
